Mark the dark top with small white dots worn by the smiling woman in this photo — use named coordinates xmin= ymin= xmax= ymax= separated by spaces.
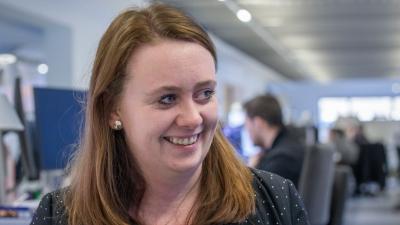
xmin=31 ymin=169 xmax=310 ymax=225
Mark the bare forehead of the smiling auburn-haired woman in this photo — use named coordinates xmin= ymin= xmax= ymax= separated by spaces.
xmin=127 ymin=40 xmax=215 ymax=88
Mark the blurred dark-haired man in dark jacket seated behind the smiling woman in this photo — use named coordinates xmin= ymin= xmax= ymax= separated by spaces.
xmin=243 ymin=95 xmax=305 ymax=186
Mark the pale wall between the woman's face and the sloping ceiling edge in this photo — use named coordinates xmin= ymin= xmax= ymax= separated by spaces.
xmin=211 ymin=34 xmax=286 ymax=120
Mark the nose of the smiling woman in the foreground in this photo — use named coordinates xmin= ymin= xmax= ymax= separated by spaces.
xmin=176 ymin=101 xmax=203 ymax=129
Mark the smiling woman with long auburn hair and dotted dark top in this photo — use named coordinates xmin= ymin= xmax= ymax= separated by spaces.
xmin=31 ymin=4 xmax=308 ymax=225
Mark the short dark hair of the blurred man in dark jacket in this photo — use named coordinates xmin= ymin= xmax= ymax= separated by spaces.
xmin=243 ymin=94 xmax=283 ymax=127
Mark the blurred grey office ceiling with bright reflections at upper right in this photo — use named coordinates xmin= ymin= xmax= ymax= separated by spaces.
xmin=163 ymin=0 xmax=400 ymax=81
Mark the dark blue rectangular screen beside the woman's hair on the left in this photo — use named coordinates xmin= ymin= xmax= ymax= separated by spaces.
xmin=34 ymin=87 xmax=85 ymax=170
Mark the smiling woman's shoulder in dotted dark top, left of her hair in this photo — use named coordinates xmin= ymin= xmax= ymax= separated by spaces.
xmin=31 ymin=189 xmax=67 ymax=225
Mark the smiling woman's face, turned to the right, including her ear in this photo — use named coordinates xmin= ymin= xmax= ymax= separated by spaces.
xmin=111 ymin=40 xmax=218 ymax=176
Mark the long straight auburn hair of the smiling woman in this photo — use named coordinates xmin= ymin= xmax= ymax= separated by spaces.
xmin=64 ymin=3 xmax=255 ymax=225
